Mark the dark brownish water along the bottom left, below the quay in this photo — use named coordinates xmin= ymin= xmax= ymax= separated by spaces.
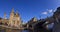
xmin=0 ymin=27 xmax=33 ymax=32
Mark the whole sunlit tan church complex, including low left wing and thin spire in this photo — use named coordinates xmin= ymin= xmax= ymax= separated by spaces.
xmin=0 ymin=8 xmax=22 ymax=27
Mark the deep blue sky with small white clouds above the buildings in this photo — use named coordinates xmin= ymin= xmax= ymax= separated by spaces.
xmin=0 ymin=0 xmax=60 ymax=23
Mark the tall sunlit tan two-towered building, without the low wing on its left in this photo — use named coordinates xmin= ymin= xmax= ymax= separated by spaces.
xmin=8 ymin=9 xmax=22 ymax=27
